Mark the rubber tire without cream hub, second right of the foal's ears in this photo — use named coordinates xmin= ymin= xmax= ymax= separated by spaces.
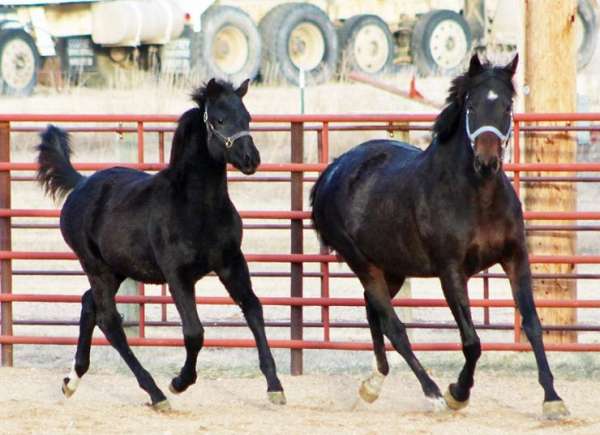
xmin=258 ymin=3 xmax=339 ymax=85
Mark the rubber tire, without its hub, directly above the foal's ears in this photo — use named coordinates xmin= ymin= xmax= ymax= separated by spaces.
xmin=191 ymin=6 xmax=262 ymax=83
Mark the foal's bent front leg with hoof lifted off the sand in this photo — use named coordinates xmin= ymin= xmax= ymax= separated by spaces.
xmin=169 ymin=277 xmax=204 ymax=394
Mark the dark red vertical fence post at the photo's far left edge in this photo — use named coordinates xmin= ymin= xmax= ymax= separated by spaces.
xmin=0 ymin=122 xmax=13 ymax=367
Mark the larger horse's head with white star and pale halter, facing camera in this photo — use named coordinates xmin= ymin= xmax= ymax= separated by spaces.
xmin=464 ymin=55 xmax=519 ymax=177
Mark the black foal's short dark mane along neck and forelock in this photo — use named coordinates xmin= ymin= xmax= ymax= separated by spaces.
xmin=170 ymin=79 xmax=235 ymax=165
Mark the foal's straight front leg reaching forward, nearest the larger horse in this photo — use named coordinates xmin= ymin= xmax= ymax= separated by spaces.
xmin=216 ymin=251 xmax=286 ymax=405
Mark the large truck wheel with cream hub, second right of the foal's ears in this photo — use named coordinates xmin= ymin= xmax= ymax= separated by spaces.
xmin=259 ymin=3 xmax=339 ymax=84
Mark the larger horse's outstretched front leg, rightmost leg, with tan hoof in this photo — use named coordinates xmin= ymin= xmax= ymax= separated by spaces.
xmin=502 ymin=246 xmax=569 ymax=419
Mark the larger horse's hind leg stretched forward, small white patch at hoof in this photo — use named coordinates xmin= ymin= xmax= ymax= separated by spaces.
xmin=358 ymin=266 xmax=446 ymax=410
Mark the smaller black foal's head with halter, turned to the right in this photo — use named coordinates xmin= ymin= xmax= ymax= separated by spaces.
xmin=195 ymin=79 xmax=260 ymax=175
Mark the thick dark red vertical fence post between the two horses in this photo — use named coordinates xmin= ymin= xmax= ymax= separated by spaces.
xmin=290 ymin=122 xmax=304 ymax=375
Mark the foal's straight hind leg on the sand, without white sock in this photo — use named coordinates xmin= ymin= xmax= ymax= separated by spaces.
xmin=89 ymin=272 xmax=170 ymax=411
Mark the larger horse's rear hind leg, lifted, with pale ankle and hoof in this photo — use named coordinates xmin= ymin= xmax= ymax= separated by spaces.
xmin=358 ymin=280 xmax=404 ymax=403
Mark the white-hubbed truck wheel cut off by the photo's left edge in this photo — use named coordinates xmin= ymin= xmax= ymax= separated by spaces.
xmin=0 ymin=29 xmax=40 ymax=96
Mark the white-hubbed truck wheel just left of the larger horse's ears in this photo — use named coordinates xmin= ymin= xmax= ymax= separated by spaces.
xmin=411 ymin=9 xmax=472 ymax=76
